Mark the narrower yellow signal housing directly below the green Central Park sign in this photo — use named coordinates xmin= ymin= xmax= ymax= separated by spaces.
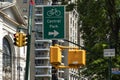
xmin=50 ymin=46 xmax=62 ymax=65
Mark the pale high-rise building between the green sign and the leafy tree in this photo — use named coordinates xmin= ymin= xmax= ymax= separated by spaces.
xmin=64 ymin=9 xmax=79 ymax=80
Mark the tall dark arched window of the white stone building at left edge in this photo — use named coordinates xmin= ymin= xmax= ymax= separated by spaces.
xmin=2 ymin=38 xmax=12 ymax=80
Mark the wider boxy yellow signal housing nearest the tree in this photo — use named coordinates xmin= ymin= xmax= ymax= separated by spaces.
xmin=68 ymin=49 xmax=86 ymax=67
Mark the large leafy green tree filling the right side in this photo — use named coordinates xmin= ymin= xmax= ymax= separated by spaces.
xmin=77 ymin=0 xmax=120 ymax=80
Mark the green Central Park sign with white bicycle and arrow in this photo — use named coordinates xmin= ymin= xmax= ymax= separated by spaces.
xmin=43 ymin=5 xmax=65 ymax=39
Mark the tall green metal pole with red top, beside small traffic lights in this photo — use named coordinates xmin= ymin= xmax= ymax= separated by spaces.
xmin=25 ymin=0 xmax=34 ymax=80
